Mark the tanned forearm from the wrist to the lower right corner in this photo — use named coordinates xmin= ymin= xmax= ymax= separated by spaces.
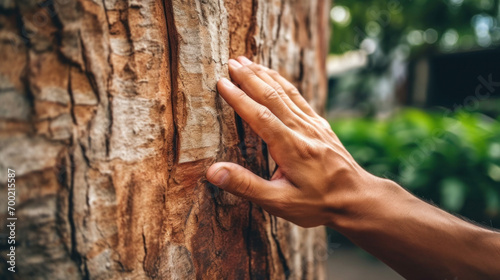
xmin=330 ymin=180 xmax=500 ymax=279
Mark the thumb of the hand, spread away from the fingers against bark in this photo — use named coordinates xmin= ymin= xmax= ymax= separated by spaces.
xmin=207 ymin=162 xmax=272 ymax=204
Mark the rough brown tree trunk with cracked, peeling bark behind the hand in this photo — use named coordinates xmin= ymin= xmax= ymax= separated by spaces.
xmin=0 ymin=0 xmax=329 ymax=279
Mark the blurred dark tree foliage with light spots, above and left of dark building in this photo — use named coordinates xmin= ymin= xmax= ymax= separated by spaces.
xmin=329 ymin=0 xmax=500 ymax=115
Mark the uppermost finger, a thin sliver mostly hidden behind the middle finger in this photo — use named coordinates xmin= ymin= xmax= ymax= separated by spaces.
xmin=238 ymin=56 xmax=307 ymax=121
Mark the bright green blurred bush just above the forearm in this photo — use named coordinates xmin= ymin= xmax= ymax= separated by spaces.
xmin=331 ymin=109 xmax=500 ymax=227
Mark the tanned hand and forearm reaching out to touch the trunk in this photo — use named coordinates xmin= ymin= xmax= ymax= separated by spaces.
xmin=207 ymin=57 xmax=500 ymax=279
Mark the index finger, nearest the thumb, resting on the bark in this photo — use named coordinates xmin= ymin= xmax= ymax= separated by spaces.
xmin=217 ymin=78 xmax=292 ymax=151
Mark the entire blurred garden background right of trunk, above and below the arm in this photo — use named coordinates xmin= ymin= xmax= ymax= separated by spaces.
xmin=327 ymin=0 xmax=500 ymax=279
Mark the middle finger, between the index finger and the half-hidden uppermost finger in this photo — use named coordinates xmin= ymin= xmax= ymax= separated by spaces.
xmin=229 ymin=59 xmax=293 ymax=123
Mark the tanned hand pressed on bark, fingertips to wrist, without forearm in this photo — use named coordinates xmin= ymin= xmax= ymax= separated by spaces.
xmin=207 ymin=57 xmax=386 ymax=227
